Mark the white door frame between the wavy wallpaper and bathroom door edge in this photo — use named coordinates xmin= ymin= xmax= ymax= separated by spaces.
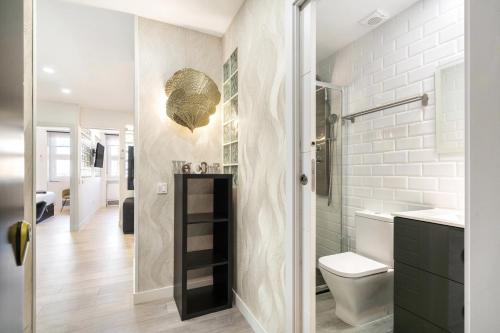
xmin=285 ymin=0 xmax=316 ymax=333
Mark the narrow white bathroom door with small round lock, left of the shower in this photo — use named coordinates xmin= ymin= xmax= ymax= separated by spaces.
xmin=299 ymin=1 xmax=316 ymax=333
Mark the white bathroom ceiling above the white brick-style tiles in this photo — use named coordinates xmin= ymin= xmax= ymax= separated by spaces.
xmin=316 ymin=0 xmax=417 ymax=61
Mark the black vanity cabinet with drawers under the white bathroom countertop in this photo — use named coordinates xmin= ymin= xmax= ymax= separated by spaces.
xmin=394 ymin=217 xmax=464 ymax=333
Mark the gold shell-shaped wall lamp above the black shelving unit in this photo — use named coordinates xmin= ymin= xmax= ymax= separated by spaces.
xmin=165 ymin=68 xmax=220 ymax=132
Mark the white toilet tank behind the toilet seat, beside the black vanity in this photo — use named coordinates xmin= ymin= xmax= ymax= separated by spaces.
xmin=354 ymin=211 xmax=394 ymax=267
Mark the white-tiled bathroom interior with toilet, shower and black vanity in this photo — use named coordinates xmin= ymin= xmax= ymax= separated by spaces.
xmin=308 ymin=0 xmax=465 ymax=333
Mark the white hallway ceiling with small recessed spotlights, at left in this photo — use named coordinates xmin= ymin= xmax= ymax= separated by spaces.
xmin=36 ymin=0 xmax=134 ymax=112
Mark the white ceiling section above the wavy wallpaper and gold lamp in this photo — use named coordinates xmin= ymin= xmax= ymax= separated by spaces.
xmin=67 ymin=0 xmax=245 ymax=37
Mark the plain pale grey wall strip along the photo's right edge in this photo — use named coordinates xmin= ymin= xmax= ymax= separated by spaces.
xmin=465 ymin=0 xmax=500 ymax=333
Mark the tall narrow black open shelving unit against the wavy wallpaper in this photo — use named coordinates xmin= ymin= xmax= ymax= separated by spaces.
xmin=174 ymin=174 xmax=233 ymax=320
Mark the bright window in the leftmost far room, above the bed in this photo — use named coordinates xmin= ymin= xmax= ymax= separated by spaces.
xmin=47 ymin=131 xmax=71 ymax=182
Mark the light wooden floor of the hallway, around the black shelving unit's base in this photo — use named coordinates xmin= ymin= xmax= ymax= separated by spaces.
xmin=36 ymin=208 xmax=252 ymax=333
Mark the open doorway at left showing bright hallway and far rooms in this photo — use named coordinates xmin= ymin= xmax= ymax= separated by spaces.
xmin=34 ymin=0 xmax=134 ymax=333
